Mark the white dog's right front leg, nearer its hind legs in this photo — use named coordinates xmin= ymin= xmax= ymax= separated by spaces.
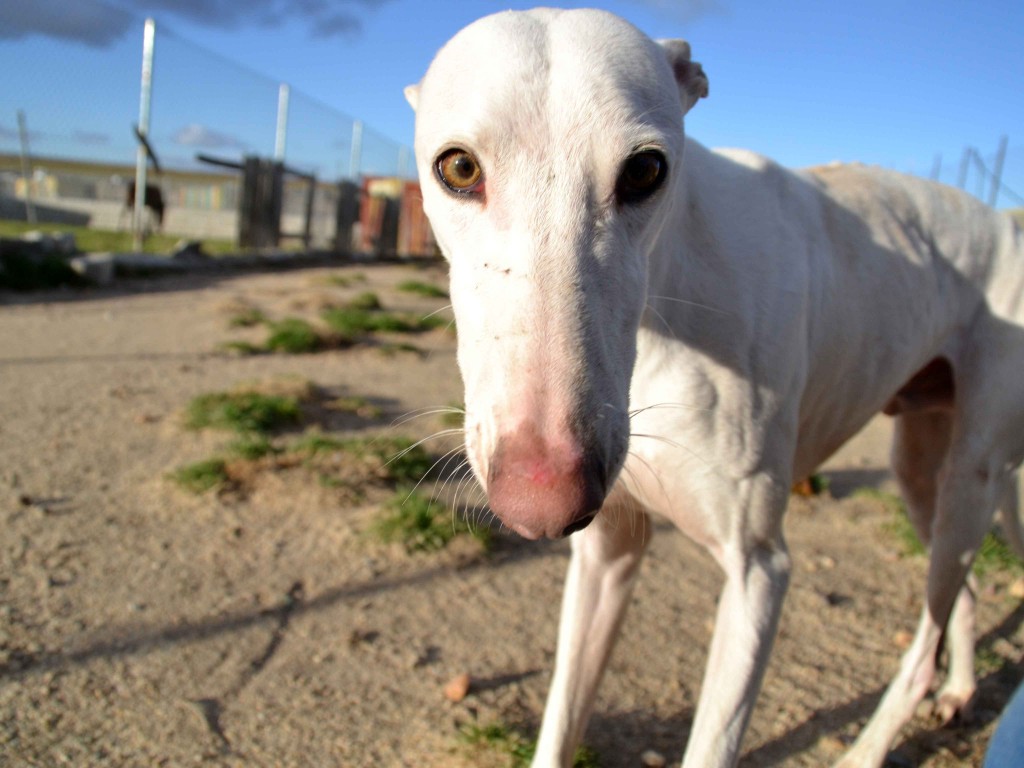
xmin=683 ymin=534 xmax=790 ymax=768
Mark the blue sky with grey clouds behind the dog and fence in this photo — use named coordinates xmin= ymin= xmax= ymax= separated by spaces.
xmin=0 ymin=0 xmax=1024 ymax=207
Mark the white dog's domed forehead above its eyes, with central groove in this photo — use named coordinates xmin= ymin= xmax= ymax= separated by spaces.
xmin=418 ymin=9 xmax=681 ymax=153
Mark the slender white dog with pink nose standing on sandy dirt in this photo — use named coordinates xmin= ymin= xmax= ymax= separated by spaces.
xmin=407 ymin=10 xmax=1024 ymax=768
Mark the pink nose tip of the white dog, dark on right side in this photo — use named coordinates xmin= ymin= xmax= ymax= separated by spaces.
xmin=487 ymin=429 xmax=606 ymax=539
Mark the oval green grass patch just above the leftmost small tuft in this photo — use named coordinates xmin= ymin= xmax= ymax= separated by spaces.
xmin=185 ymin=391 xmax=301 ymax=434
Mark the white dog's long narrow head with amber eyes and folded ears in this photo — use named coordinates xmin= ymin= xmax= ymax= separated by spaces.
xmin=407 ymin=10 xmax=708 ymax=538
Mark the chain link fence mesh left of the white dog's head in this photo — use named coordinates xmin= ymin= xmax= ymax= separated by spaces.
xmin=0 ymin=12 xmax=415 ymax=247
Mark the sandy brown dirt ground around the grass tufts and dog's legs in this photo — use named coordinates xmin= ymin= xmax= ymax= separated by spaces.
xmin=0 ymin=265 xmax=1024 ymax=768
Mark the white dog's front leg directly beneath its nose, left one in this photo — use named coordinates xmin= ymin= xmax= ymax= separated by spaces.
xmin=532 ymin=502 xmax=651 ymax=768
